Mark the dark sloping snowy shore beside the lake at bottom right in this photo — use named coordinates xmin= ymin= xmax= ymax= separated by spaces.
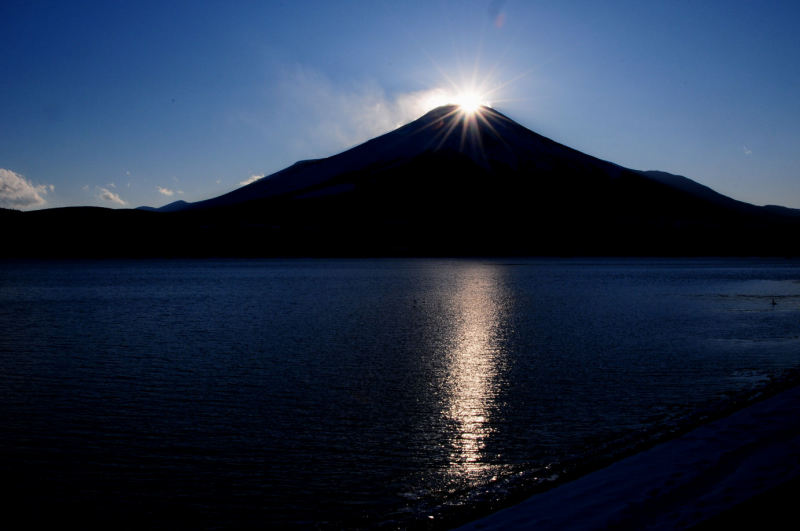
xmin=457 ymin=374 xmax=800 ymax=530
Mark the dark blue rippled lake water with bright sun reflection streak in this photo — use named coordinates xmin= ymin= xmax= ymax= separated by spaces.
xmin=0 ymin=259 xmax=800 ymax=528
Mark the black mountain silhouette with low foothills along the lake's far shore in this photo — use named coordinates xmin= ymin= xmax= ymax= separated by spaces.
xmin=1 ymin=106 xmax=800 ymax=256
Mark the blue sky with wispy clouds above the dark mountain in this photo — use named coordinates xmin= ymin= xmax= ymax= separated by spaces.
xmin=0 ymin=0 xmax=800 ymax=208
